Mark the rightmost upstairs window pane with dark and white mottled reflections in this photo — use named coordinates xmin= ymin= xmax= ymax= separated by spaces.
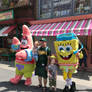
xmin=74 ymin=0 xmax=91 ymax=14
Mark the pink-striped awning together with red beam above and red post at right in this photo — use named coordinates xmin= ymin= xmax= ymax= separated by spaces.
xmin=30 ymin=15 xmax=92 ymax=68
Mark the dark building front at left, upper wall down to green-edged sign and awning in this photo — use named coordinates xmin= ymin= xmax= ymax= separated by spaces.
xmin=0 ymin=0 xmax=36 ymax=60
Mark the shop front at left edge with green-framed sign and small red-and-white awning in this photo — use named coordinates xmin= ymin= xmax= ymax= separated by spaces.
xmin=0 ymin=10 xmax=16 ymax=61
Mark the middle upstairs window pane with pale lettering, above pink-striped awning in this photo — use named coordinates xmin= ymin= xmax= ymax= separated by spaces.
xmin=53 ymin=0 xmax=72 ymax=17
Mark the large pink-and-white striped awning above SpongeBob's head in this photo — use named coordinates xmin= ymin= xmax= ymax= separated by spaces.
xmin=30 ymin=19 xmax=92 ymax=36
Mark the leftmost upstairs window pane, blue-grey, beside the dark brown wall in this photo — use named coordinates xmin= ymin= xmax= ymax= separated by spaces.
xmin=40 ymin=0 xmax=52 ymax=18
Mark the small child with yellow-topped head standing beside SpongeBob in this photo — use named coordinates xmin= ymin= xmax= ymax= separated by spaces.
xmin=48 ymin=55 xmax=57 ymax=91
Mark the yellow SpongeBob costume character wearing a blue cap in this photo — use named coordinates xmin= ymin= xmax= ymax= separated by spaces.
xmin=54 ymin=33 xmax=83 ymax=92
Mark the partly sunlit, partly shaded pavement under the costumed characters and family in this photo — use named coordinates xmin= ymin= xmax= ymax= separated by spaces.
xmin=0 ymin=61 xmax=92 ymax=92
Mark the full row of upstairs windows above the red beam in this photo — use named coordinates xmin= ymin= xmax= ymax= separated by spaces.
xmin=37 ymin=0 xmax=92 ymax=19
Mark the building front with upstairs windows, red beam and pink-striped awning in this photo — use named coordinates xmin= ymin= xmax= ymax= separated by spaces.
xmin=29 ymin=0 xmax=92 ymax=70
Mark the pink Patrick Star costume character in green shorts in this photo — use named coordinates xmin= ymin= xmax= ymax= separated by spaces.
xmin=10 ymin=25 xmax=36 ymax=86
